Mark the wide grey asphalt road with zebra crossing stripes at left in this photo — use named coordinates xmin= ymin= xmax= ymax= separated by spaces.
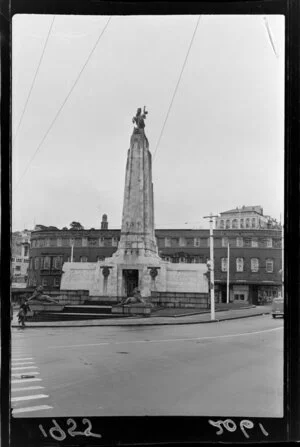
xmin=11 ymin=315 xmax=283 ymax=417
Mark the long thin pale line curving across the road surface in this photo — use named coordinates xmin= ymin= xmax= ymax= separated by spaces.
xmin=48 ymin=326 xmax=283 ymax=349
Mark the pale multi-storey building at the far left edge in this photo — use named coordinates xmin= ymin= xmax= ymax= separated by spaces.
xmin=11 ymin=230 xmax=30 ymax=288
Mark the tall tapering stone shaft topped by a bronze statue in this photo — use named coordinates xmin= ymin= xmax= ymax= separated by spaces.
xmin=115 ymin=107 xmax=159 ymax=262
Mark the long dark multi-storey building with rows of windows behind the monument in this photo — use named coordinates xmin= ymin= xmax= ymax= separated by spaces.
xmin=28 ymin=215 xmax=282 ymax=304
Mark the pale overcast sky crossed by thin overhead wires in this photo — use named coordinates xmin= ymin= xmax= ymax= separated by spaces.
xmin=12 ymin=15 xmax=285 ymax=231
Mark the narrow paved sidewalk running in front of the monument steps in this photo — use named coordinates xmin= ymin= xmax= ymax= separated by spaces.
xmin=12 ymin=306 xmax=271 ymax=328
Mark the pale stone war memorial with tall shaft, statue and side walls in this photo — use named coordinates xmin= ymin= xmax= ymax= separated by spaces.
xmin=60 ymin=107 xmax=208 ymax=308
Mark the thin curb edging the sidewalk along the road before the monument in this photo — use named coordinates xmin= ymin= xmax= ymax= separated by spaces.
xmin=11 ymin=312 xmax=271 ymax=329
